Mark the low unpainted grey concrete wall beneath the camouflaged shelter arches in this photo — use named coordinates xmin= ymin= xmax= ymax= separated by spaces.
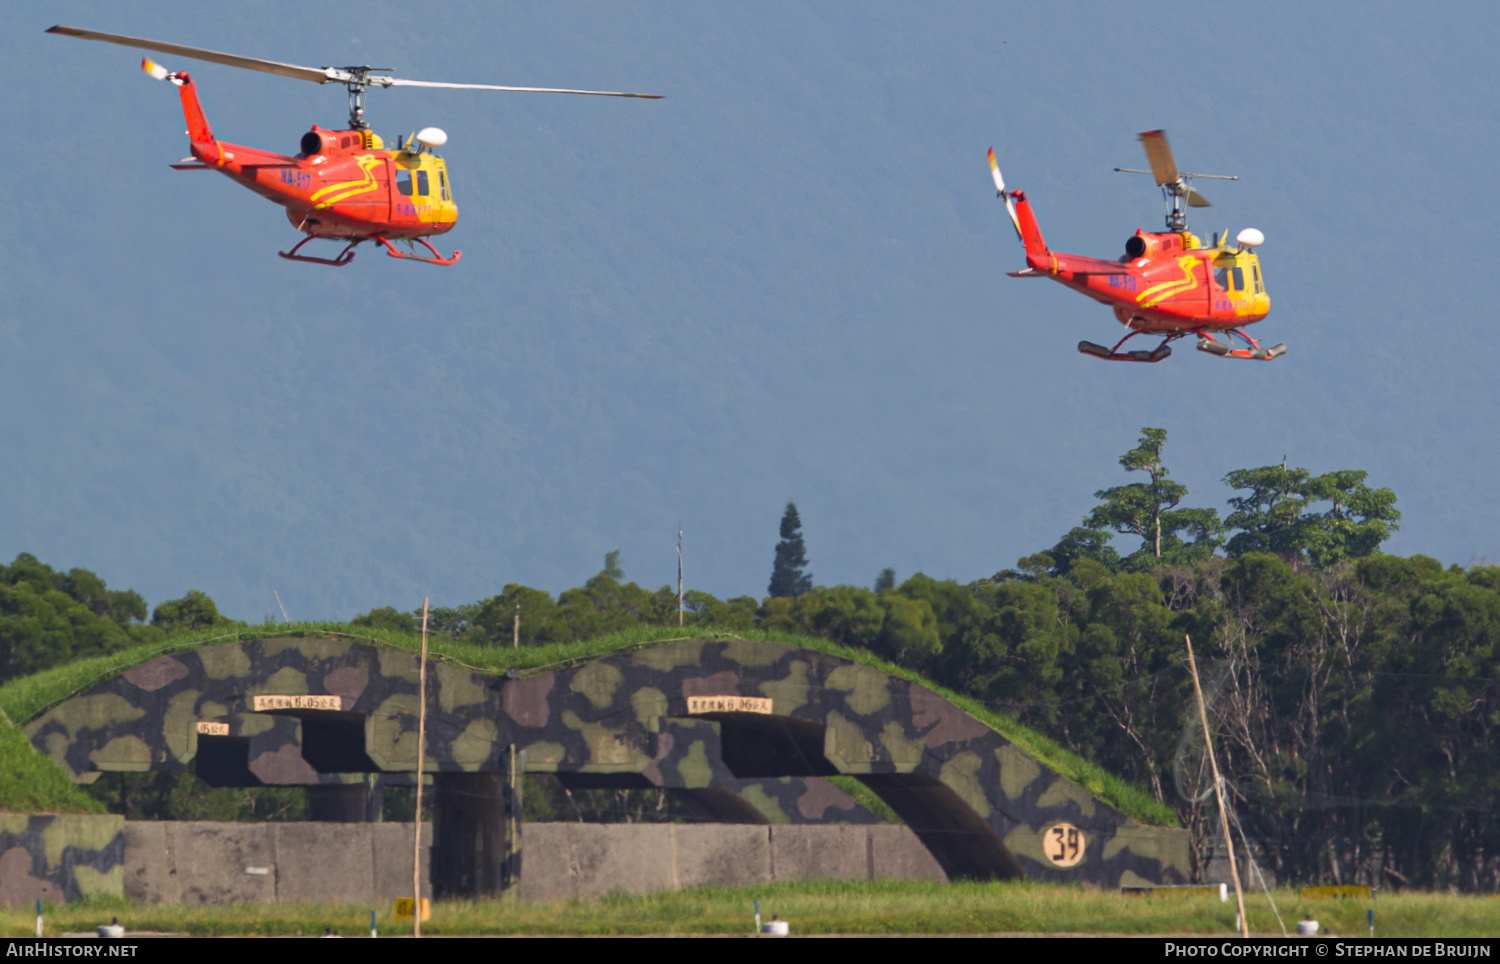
xmin=125 ymin=820 xmax=945 ymax=904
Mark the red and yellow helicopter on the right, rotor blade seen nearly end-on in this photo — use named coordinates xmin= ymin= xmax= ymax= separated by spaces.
xmin=990 ymin=130 xmax=1287 ymax=361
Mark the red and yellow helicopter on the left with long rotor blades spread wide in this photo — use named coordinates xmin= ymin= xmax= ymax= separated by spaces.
xmin=47 ymin=27 xmax=662 ymax=265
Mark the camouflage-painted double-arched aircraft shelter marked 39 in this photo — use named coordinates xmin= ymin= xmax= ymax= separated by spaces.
xmin=26 ymin=636 xmax=1190 ymax=895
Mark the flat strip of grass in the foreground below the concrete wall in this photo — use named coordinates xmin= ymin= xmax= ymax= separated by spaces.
xmin=0 ymin=882 xmax=1500 ymax=937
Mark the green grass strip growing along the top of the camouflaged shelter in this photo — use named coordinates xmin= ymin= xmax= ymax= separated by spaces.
xmin=0 ymin=624 xmax=1178 ymax=826
